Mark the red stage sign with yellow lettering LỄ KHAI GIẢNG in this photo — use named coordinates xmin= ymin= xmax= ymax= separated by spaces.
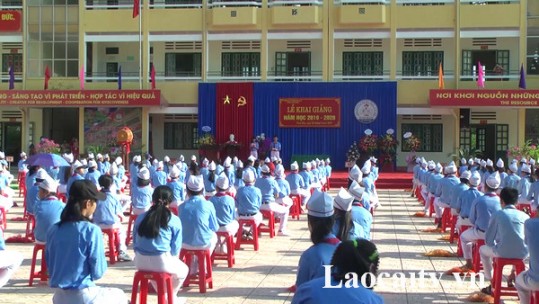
xmin=279 ymin=98 xmax=341 ymax=128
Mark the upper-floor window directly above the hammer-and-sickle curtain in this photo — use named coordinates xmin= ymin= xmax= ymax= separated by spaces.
xmin=221 ymin=53 xmax=260 ymax=77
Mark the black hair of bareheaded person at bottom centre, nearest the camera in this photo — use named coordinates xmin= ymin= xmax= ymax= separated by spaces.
xmin=331 ymin=239 xmax=380 ymax=287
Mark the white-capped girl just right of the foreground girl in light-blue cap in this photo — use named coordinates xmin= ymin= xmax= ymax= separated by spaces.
xmin=332 ymin=187 xmax=363 ymax=241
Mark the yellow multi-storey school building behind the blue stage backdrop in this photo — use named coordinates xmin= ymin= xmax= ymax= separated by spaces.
xmin=0 ymin=0 xmax=539 ymax=166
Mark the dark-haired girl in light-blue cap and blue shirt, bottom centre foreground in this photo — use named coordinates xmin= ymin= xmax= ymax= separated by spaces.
xmin=291 ymin=190 xmax=341 ymax=290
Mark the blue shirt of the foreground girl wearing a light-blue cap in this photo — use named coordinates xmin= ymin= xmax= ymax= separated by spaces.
xmin=296 ymin=233 xmax=340 ymax=288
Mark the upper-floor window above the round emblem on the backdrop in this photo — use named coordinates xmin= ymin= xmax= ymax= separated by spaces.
xmin=342 ymin=52 xmax=384 ymax=76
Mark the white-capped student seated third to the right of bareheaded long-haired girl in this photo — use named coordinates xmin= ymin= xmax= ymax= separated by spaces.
xmin=235 ymin=170 xmax=262 ymax=226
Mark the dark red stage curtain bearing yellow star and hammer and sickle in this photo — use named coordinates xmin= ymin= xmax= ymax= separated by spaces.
xmin=216 ymin=82 xmax=254 ymax=159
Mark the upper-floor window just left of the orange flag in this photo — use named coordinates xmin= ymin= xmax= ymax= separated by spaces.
xmin=402 ymin=51 xmax=444 ymax=76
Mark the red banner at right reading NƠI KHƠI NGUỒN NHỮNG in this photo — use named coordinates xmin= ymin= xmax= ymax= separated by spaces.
xmin=429 ymin=90 xmax=539 ymax=108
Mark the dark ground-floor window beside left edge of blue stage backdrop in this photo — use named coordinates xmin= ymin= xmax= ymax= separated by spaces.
xmin=164 ymin=122 xmax=198 ymax=150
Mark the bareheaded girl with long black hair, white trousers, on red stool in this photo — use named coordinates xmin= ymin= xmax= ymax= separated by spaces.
xmin=133 ymin=186 xmax=189 ymax=303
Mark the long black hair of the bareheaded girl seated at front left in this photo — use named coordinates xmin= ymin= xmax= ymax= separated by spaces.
xmin=137 ymin=186 xmax=173 ymax=239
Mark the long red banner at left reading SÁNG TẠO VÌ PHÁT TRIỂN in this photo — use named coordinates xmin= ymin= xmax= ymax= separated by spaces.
xmin=0 ymin=90 xmax=161 ymax=108
